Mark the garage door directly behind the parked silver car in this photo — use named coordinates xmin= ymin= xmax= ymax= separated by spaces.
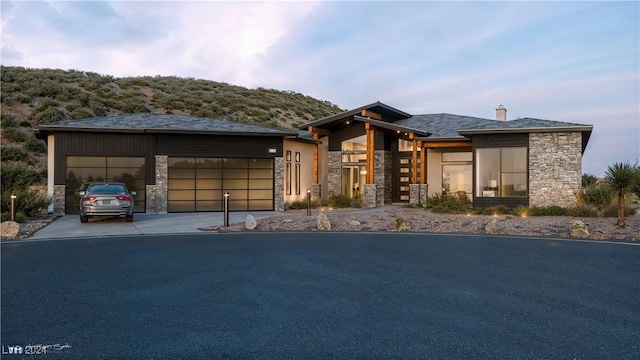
xmin=65 ymin=156 xmax=146 ymax=214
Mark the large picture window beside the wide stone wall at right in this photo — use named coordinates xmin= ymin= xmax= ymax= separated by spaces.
xmin=476 ymin=147 xmax=528 ymax=197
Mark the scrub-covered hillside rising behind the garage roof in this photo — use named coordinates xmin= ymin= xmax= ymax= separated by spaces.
xmin=0 ymin=66 xmax=342 ymax=173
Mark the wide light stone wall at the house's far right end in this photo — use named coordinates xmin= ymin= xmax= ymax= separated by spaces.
xmin=529 ymin=132 xmax=582 ymax=207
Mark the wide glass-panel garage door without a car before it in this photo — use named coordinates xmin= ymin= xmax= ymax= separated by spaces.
xmin=168 ymin=157 xmax=274 ymax=212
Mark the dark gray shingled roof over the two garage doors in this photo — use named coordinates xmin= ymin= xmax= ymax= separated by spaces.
xmin=39 ymin=114 xmax=297 ymax=136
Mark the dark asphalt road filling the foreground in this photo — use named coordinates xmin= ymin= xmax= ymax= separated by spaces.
xmin=1 ymin=233 xmax=640 ymax=359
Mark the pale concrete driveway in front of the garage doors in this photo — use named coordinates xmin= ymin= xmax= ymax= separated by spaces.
xmin=30 ymin=211 xmax=285 ymax=240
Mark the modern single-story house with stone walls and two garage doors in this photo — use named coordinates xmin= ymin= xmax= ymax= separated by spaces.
xmin=39 ymin=102 xmax=593 ymax=213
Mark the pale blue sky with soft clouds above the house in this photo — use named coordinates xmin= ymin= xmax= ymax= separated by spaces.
xmin=0 ymin=0 xmax=640 ymax=176
